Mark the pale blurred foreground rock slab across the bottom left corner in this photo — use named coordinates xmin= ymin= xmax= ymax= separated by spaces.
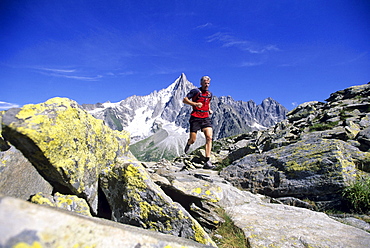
xmin=0 ymin=196 xmax=214 ymax=248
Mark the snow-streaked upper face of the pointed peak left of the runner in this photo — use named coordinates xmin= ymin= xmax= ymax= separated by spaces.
xmin=83 ymin=74 xmax=195 ymax=140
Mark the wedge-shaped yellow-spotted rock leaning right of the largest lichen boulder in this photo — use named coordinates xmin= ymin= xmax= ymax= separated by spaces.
xmin=100 ymin=159 xmax=214 ymax=245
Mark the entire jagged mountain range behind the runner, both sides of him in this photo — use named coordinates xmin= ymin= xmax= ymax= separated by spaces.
xmin=83 ymin=74 xmax=287 ymax=161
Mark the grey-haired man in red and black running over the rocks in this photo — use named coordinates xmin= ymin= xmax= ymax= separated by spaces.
xmin=183 ymin=76 xmax=214 ymax=169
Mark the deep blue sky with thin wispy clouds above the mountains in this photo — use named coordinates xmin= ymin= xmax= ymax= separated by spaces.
xmin=0 ymin=0 xmax=370 ymax=109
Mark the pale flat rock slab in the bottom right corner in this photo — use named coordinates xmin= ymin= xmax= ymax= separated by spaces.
xmin=226 ymin=203 xmax=370 ymax=248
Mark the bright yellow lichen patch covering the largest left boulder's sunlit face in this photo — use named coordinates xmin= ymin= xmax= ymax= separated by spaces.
xmin=13 ymin=98 xmax=129 ymax=172
